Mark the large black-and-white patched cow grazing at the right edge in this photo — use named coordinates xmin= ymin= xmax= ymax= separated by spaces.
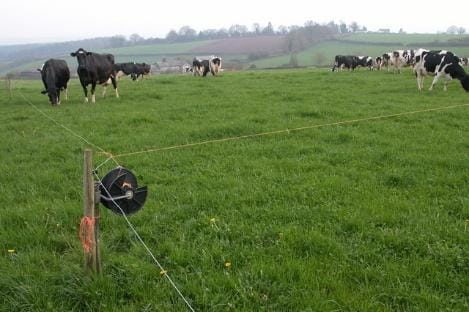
xmin=414 ymin=51 xmax=469 ymax=92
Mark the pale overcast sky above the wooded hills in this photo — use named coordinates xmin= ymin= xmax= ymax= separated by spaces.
xmin=0 ymin=0 xmax=469 ymax=44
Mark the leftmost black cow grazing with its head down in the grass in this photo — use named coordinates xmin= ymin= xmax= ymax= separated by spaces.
xmin=38 ymin=59 xmax=70 ymax=105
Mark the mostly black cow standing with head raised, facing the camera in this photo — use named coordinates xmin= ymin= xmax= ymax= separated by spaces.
xmin=70 ymin=48 xmax=119 ymax=103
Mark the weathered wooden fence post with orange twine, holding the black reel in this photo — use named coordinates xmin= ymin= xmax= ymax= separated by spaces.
xmin=83 ymin=149 xmax=101 ymax=273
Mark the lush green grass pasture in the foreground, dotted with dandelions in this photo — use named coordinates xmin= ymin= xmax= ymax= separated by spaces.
xmin=0 ymin=70 xmax=469 ymax=311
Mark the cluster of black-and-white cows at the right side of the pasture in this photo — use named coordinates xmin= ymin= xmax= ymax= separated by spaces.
xmin=332 ymin=49 xmax=469 ymax=92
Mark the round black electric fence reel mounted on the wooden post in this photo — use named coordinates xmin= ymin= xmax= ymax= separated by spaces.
xmin=99 ymin=167 xmax=148 ymax=215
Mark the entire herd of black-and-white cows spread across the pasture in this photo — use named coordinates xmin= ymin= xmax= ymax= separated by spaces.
xmin=38 ymin=48 xmax=469 ymax=105
